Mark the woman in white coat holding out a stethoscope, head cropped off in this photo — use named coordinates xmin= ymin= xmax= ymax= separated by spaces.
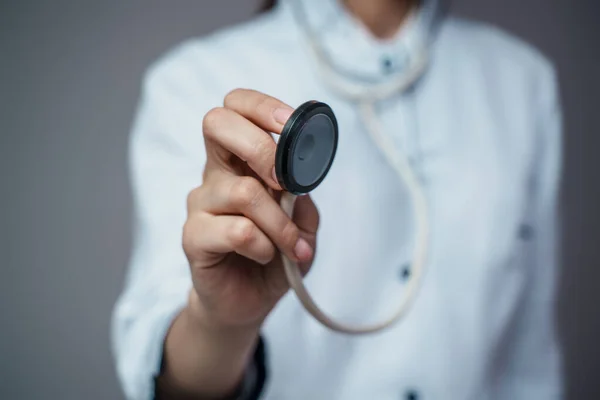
xmin=113 ymin=0 xmax=561 ymax=400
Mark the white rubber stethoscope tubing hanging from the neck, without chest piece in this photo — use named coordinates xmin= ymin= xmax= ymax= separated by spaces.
xmin=281 ymin=1 xmax=429 ymax=334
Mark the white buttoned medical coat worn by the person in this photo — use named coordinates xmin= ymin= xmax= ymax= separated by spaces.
xmin=113 ymin=0 xmax=562 ymax=400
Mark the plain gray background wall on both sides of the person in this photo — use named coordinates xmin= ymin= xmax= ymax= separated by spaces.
xmin=0 ymin=0 xmax=600 ymax=399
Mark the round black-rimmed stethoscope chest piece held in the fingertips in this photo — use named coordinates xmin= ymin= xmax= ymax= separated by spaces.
xmin=275 ymin=101 xmax=338 ymax=194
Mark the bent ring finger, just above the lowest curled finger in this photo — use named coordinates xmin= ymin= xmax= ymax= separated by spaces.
xmin=188 ymin=173 xmax=311 ymax=261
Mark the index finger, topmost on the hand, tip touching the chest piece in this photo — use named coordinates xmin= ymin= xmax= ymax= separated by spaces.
xmin=223 ymin=89 xmax=294 ymax=134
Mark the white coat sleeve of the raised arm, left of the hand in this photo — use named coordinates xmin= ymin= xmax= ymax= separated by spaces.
xmin=112 ymin=54 xmax=208 ymax=400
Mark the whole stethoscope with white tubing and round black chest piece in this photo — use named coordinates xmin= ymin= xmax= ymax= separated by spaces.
xmin=275 ymin=0 xmax=429 ymax=334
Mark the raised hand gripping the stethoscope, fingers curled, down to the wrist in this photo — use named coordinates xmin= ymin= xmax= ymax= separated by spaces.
xmin=183 ymin=89 xmax=319 ymax=328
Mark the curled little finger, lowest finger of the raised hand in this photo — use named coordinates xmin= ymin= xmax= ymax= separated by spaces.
xmin=184 ymin=213 xmax=276 ymax=267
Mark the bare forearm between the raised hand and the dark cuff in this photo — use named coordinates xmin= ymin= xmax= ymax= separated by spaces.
xmin=161 ymin=290 xmax=259 ymax=400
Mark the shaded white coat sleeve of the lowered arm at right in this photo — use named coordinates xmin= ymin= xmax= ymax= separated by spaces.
xmin=494 ymin=66 xmax=563 ymax=400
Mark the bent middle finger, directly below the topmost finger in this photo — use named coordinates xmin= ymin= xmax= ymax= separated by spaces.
xmin=203 ymin=108 xmax=281 ymax=190
